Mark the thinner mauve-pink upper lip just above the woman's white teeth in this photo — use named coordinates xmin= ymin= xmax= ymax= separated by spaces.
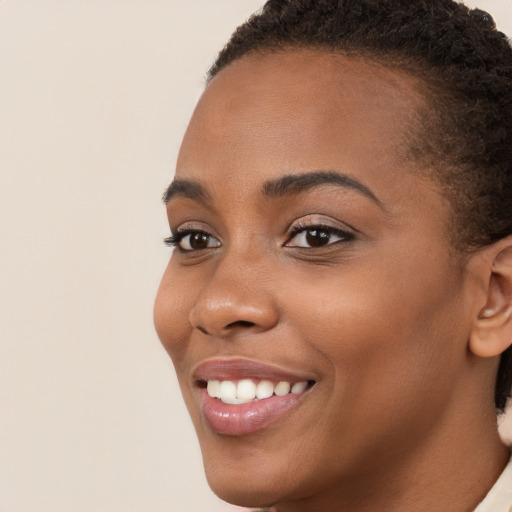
xmin=192 ymin=358 xmax=316 ymax=382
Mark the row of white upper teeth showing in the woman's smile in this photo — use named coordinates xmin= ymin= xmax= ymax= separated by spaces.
xmin=206 ymin=379 xmax=308 ymax=404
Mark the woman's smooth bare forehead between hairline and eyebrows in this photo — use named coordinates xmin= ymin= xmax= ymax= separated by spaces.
xmin=176 ymin=50 xmax=428 ymax=198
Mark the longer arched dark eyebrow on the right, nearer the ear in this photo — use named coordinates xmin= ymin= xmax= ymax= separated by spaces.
xmin=262 ymin=170 xmax=383 ymax=208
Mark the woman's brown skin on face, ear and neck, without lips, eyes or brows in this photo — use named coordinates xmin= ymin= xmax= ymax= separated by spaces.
xmin=155 ymin=51 xmax=512 ymax=512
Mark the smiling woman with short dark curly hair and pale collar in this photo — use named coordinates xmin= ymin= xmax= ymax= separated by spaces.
xmin=155 ymin=0 xmax=512 ymax=512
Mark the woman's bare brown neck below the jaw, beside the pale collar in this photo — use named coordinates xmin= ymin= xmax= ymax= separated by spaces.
xmin=272 ymin=406 xmax=510 ymax=512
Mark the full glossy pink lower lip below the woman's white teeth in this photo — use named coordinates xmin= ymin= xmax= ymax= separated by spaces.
xmin=201 ymin=390 xmax=302 ymax=436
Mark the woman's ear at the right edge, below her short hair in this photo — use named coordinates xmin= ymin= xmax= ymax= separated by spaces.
xmin=469 ymin=237 xmax=512 ymax=357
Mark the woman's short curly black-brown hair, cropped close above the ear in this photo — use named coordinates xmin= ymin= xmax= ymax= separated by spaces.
xmin=208 ymin=0 xmax=512 ymax=411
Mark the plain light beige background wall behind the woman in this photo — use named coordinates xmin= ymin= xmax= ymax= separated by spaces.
xmin=0 ymin=0 xmax=512 ymax=512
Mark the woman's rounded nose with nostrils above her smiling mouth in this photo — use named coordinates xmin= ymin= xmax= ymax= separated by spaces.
xmin=189 ymin=260 xmax=279 ymax=338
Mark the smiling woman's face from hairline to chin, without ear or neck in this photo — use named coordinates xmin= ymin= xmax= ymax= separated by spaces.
xmin=155 ymin=51 xmax=478 ymax=510
